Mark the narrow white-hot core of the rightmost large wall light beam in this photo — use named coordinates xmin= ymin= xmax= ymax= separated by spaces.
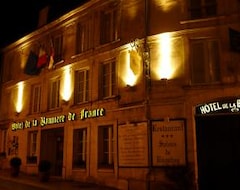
xmin=157 ymin=33 xmax=174 ymax=79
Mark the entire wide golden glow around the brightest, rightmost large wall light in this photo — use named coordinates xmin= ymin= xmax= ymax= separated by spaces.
xmin=150 ymin=33 xmax=184 ymax=80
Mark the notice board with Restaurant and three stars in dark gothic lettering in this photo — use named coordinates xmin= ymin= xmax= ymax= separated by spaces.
xmin=151 ymin=120 xmax=186 ymax=166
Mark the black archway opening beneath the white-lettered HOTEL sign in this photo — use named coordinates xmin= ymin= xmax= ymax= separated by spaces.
xmin=196 ymin=115 xmax=240 ymax=190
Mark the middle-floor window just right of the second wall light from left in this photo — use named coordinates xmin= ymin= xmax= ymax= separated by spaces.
xmin=74 ymin=70 xmax=89 ymax=104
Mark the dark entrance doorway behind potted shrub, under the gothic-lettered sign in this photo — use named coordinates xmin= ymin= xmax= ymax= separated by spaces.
xmin=40 ymin=128 xmax=64 ymax=176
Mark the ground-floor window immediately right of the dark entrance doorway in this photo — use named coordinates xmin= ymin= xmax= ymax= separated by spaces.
xmin=72 ymin=128 xmax=87 ymax=168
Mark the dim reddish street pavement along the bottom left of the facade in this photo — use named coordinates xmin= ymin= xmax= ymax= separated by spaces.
xmin=0 ymin=169 xmax=117 ymax=190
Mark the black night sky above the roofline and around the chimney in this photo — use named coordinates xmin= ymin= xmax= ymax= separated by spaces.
xmin=0 ymin=0 xmax=88 ymax=48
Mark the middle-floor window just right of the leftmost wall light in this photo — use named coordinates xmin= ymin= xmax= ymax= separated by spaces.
xmin=31 ymin=84 xmax=41 ymax=113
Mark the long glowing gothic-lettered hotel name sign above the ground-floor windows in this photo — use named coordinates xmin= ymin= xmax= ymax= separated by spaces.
xmin=11 ymin=108 xmax=106 ymax=131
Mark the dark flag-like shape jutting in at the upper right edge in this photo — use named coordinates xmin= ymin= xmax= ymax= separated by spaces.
xmin=229 ymin=28 xmax=240 ymax=53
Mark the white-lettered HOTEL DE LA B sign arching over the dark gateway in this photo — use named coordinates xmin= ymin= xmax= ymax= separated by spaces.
xmin=196 ymin=98 xmax=240 ymax=115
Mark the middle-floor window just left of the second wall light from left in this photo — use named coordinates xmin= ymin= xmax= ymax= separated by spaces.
xmin=48 ymin=78 xmax=60 ymax=110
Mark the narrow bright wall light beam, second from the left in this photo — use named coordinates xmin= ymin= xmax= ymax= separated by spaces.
xmin=61 ymin=66 xmax=73 ymax=101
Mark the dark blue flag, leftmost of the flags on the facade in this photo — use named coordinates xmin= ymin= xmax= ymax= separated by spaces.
xmin=24 ymin=51 xmax=40 ymax=75
